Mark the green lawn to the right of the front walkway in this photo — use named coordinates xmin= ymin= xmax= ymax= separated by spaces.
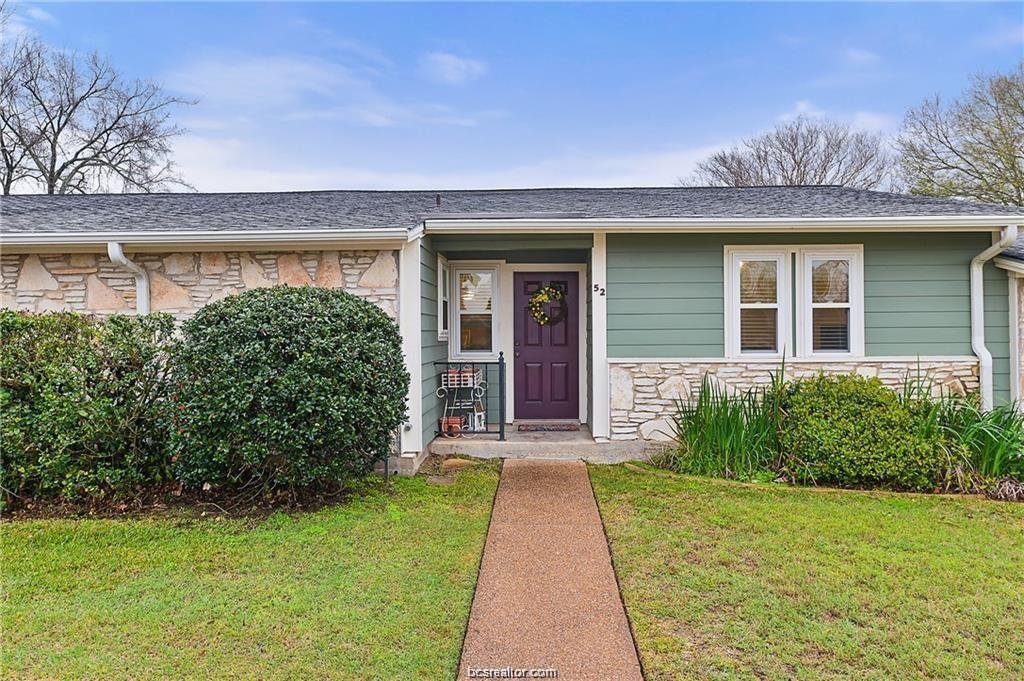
xmin=590 ymin=466 xmax=1024 ymax=679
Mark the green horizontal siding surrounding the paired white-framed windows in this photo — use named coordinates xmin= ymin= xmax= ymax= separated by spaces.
xmin=607 ymin=233 xmax=1010 ymax=399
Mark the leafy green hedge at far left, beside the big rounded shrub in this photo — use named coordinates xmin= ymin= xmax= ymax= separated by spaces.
xmin=0 ymin=310 xmax=174 ymax=501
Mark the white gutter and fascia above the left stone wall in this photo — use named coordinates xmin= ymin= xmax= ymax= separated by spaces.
xmin=0 ymin=227 xmax=409 ymax=248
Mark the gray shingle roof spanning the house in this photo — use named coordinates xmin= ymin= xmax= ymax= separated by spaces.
xmin=0 ymin=186 xmax=1021 ymax=232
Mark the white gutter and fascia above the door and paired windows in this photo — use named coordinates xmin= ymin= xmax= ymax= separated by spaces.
xmin=424 ymin=215 xmax=1024 ymax=235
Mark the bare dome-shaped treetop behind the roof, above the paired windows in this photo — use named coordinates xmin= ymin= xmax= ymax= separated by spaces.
xmin=684 ymin=116 xmax=893 ymax=189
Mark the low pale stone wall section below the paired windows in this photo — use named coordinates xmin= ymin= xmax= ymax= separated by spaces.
xmin=609 ymin=359 xmax=979 ymax=440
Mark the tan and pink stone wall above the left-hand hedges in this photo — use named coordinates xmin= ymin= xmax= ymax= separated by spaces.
xmin=0 ymin=251 xmax=398 ymax=318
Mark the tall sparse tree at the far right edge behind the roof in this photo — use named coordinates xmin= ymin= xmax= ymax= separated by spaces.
xmin=898 ymin=61 xmax=1024 ymax=206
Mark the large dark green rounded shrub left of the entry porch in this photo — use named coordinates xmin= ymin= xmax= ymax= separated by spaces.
xmin=172 ymin=287 xmax=409 ymax=492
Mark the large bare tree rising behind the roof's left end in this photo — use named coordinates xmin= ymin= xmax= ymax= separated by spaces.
xmin=0 ymin=31 xmax=191 ymax=194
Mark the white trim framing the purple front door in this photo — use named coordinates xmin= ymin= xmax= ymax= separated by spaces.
xmin=498 ymin=262 xmax=590 ymax=423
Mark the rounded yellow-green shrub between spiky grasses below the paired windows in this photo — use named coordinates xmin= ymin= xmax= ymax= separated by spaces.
xmin=780 ymin=375 xmax=950 ymax=491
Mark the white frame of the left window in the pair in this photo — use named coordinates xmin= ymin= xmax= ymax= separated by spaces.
xmin=725 ymin=246 xmax=793 ymax=358
